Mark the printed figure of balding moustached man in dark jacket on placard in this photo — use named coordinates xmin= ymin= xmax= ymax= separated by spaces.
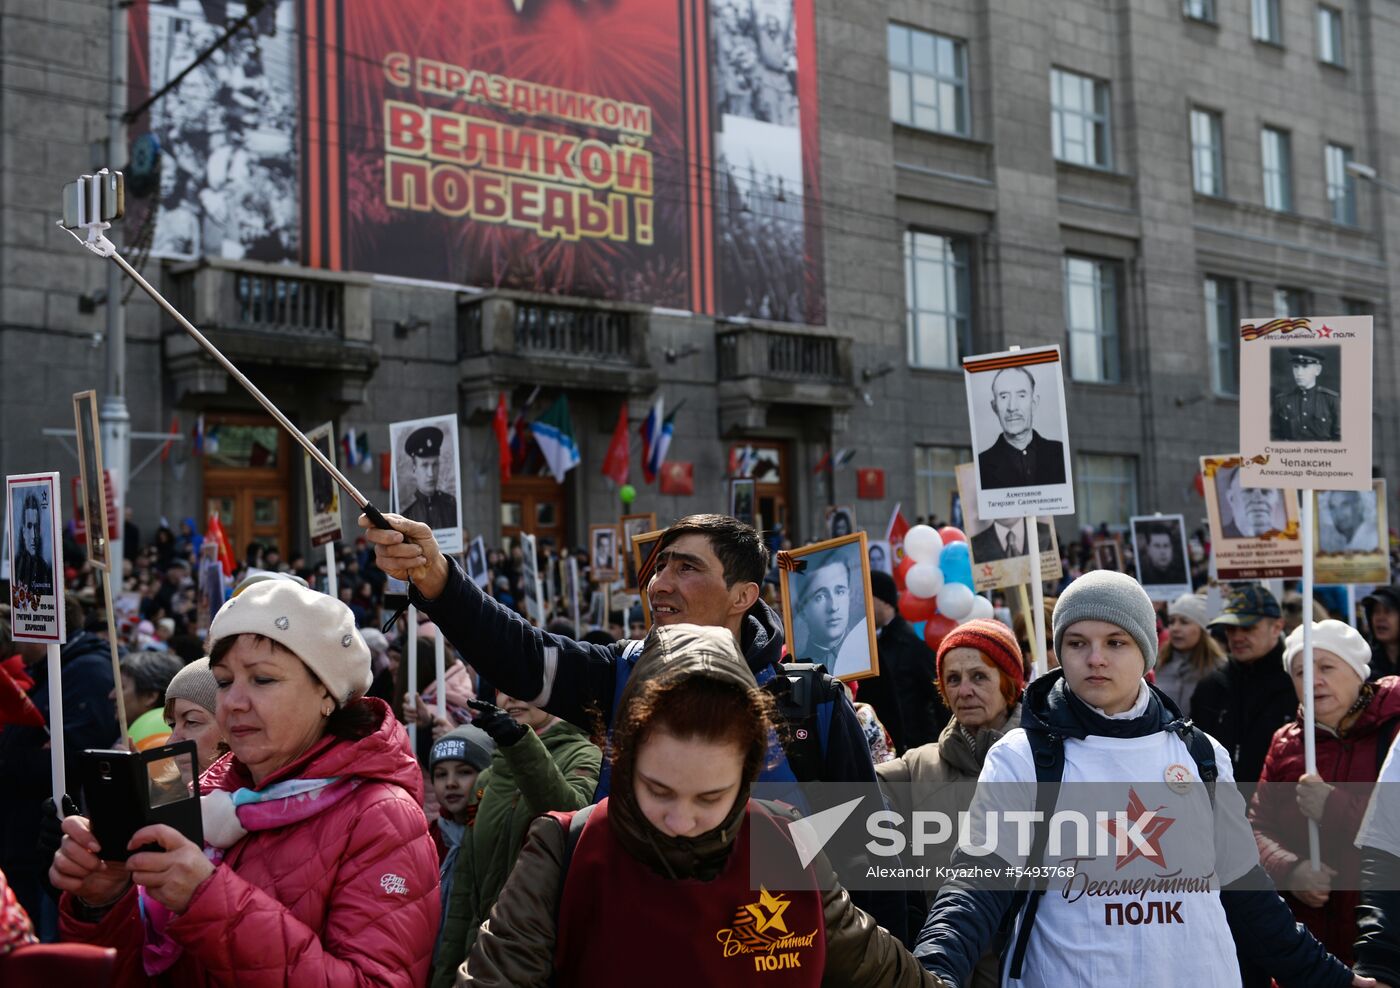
xmin=977 ymin=367 xmax=1064 ymax=490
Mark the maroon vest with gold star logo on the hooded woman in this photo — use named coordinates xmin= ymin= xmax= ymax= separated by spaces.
xmin=552 ymin=799 xmax=826 ymax=988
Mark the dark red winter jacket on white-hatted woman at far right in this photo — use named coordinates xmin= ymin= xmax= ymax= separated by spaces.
xmin=1249 ymin=676 xmax=1400 ymax=964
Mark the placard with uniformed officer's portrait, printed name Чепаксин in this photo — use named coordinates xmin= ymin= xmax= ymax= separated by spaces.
xmin=1239 ymin=316 xmax=1372 ymax=491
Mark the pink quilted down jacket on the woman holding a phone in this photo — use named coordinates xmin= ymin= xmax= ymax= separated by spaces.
xmin=59 ymin=700 xmax=440 ymax=988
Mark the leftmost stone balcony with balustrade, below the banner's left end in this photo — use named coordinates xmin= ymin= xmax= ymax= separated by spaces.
xmin=162 ymin=257 xmax=379 ymax=403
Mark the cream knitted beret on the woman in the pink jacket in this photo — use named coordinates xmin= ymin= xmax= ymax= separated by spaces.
xmin=209 ymin=579 xmax=372 ymax=705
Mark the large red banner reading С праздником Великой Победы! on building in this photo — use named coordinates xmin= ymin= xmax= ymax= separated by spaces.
xmin=132 ymin=0 xmax=825 ymax=323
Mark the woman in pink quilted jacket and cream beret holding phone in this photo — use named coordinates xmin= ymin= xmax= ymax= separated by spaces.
xmin=49 ymin=581 xmax=440 ymax=988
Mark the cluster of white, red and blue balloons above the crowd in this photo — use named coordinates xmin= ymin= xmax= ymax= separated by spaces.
xmin=895 ymin=525 xmax=993 ymax=648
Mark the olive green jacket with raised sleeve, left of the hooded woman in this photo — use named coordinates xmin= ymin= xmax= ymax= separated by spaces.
xmin=433 ymin=721 xmax=603 ymax=988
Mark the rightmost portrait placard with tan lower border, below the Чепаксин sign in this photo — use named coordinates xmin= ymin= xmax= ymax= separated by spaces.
xmin=1313 ymin=480 xmax=1390 ymax=585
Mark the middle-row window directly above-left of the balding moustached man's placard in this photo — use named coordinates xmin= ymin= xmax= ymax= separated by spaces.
xmin=904 ymin=230 xmax=972 ymax=369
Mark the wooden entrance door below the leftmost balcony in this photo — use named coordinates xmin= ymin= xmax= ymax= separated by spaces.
xmin=203 ymin=413 xmax=294 ymax=561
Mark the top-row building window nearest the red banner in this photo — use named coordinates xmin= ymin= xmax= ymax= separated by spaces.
xmin=889 ymin=24 xmax=970 ymax=137
